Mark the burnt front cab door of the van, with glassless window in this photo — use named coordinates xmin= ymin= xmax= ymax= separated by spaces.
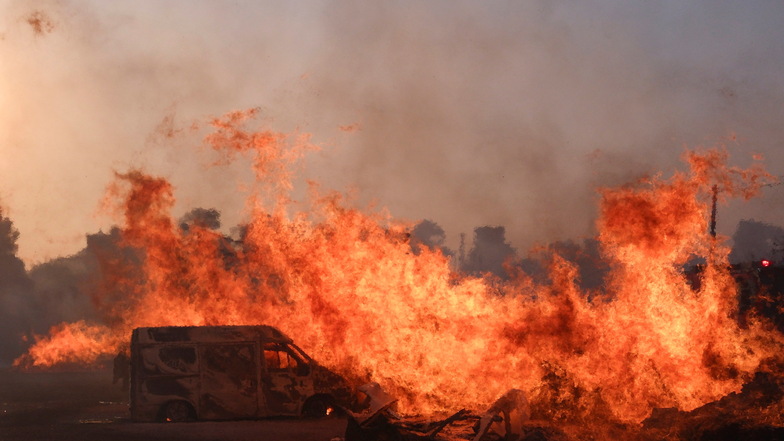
xmin=262 ymin=343 xmax=313 ymax=415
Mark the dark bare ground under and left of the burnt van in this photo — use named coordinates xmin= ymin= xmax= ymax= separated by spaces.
xmin=0 ymin=369 xmax=346 ymax=441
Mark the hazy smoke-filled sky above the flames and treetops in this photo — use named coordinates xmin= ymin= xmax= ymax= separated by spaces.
xmin=0 ymin=0 xmax=784 ymax=265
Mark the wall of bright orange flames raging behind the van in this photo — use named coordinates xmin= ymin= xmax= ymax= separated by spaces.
xmin=13 ymin=111 xmax=782 ymax=421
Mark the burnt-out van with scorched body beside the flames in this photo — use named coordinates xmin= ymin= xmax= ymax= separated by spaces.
xmin=130 ymin=326 xmax=352 ymax=421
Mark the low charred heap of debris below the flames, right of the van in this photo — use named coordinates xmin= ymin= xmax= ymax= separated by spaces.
xmin=344 ymin=372 xmax=784 ymax=441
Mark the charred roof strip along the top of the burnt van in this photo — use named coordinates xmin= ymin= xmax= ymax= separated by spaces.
xmin=131 ymin=325 xmax=292 ymax=344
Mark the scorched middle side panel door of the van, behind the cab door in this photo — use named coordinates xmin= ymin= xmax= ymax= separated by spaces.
xmin=199 ymin=343 xmax=259 ymax=419
